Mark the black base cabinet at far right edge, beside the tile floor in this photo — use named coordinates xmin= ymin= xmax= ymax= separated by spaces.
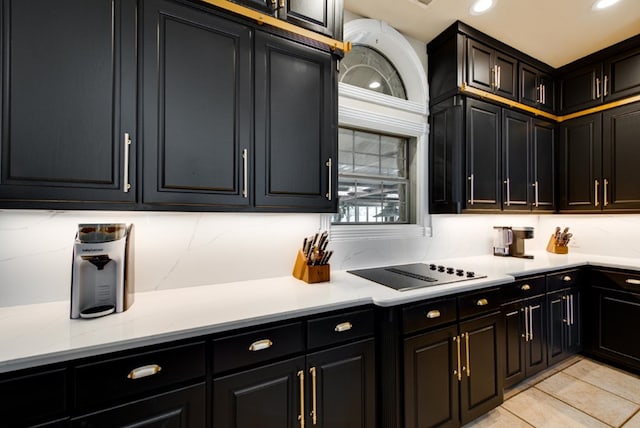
xmin=589 ymin=269 xmax=640 ymax=371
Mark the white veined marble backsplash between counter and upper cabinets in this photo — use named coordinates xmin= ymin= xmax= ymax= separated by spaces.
xmin=0 ymin=210 xmax=640 ymax=306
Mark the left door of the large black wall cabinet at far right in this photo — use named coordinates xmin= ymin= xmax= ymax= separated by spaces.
xmin=558 ymin=114 xmax=603 ymax=211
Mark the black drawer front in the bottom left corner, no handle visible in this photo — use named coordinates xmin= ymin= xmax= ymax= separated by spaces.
xmin=0 ymin=369 xmax=68 ymax=426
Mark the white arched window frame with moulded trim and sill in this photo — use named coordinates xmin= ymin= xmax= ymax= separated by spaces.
xmin=320 ymin=19 xmax=431 ymax=241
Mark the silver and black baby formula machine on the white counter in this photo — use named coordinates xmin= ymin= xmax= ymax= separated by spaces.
xmin=71 ymin=223 xmax=134 ymax=319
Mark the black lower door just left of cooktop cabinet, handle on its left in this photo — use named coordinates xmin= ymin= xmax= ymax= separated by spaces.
xmin=306 ymin=339 xmax=376 ymax=428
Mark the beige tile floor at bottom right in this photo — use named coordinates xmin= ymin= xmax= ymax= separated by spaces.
xmin=465 ymin=356 xmax=640 ymax=428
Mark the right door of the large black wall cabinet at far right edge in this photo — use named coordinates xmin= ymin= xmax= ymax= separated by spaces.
xmin=602 ymin=103 xmax=640 ymax=210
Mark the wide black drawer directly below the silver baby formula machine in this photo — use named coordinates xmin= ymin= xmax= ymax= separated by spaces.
xmin=74 ymin=342 xmax=205 ymax=408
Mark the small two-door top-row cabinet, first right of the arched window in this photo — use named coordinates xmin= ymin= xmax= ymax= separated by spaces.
xmin=467 ymin=39 xmax=518 ymax=100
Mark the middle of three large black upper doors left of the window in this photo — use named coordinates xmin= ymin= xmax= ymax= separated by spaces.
xmin=143 ymin=0 xmax=252 ymax=206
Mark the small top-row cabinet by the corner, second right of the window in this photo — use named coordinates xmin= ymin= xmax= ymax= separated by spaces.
xmin=519 ymin=63 xmax=555 ymax=113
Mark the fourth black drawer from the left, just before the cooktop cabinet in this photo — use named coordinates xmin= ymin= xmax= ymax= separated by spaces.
xmin=307 ymin=309 xmax=374 ymax=349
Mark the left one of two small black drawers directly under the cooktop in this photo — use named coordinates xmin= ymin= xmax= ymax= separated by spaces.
xmin=402 ymin=297 xmax=457 ymax=334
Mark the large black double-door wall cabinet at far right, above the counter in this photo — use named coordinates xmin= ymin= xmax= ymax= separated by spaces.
xmin=560 ymin=103 xmax=640 ymax=212
